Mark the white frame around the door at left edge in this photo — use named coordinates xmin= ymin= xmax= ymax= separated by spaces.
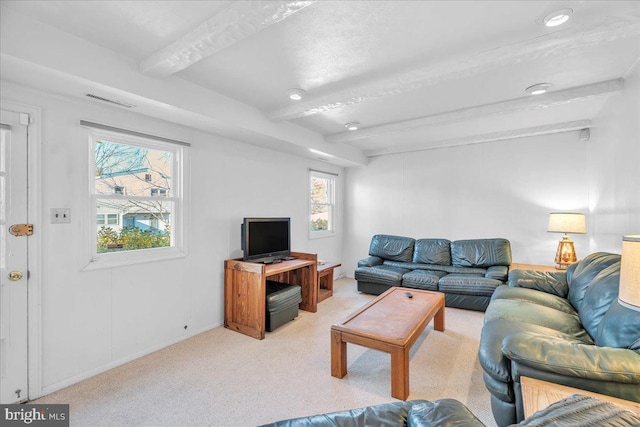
xmin=0 ymin=98 xmax=44 ymax=400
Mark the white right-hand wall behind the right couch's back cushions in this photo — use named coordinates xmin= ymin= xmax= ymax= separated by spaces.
xmin=588 ymin=63 xmax=640 ymax=253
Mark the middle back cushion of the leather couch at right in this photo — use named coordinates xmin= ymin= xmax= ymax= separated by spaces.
xmin=580 ymin=262 xmax=620 ymax=343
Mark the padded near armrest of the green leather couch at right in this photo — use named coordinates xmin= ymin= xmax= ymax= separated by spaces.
xmin=502 ymin=332 xmax=640 ymax=385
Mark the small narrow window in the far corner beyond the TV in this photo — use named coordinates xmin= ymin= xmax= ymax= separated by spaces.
xmin=309 ymin=171 xmax=336 ymax=238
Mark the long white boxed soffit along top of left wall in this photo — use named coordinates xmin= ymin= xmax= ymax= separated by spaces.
xmin=0 ymin=9 xmax=368 ymax=167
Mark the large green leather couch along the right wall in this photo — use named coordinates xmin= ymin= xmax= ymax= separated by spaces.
xmin=479 ymin=252 xmax=640 ymax=426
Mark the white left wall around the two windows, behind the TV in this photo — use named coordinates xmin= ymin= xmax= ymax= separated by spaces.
xmin=1 ymin=82 xmax=344 ymax=393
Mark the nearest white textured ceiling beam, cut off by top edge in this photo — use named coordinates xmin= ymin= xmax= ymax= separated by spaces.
xmin=140 ymin=0 xmax=315 ymax=77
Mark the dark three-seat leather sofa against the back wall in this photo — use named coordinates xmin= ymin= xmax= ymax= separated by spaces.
xmin=354 ymin=234 xmax=511 ymax=311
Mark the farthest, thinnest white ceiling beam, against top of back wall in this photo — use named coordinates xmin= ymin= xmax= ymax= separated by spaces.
xmin=364 ymin=120 xmax=591 ymax=157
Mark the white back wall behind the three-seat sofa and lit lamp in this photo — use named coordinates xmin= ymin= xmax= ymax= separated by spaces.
xmin=344 ymin=132 xmax=588 ymax=270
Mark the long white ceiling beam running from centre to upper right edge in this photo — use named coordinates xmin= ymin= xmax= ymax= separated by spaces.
xmin=268 ymin=10 xmax=640 ymax=121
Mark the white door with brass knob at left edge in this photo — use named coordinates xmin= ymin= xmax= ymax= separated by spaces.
xmin=0 ymin=110 xmax=29 ymax=404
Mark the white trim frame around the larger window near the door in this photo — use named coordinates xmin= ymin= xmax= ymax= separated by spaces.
xmin=81 ymin=123 xmax=190 ymax=271
